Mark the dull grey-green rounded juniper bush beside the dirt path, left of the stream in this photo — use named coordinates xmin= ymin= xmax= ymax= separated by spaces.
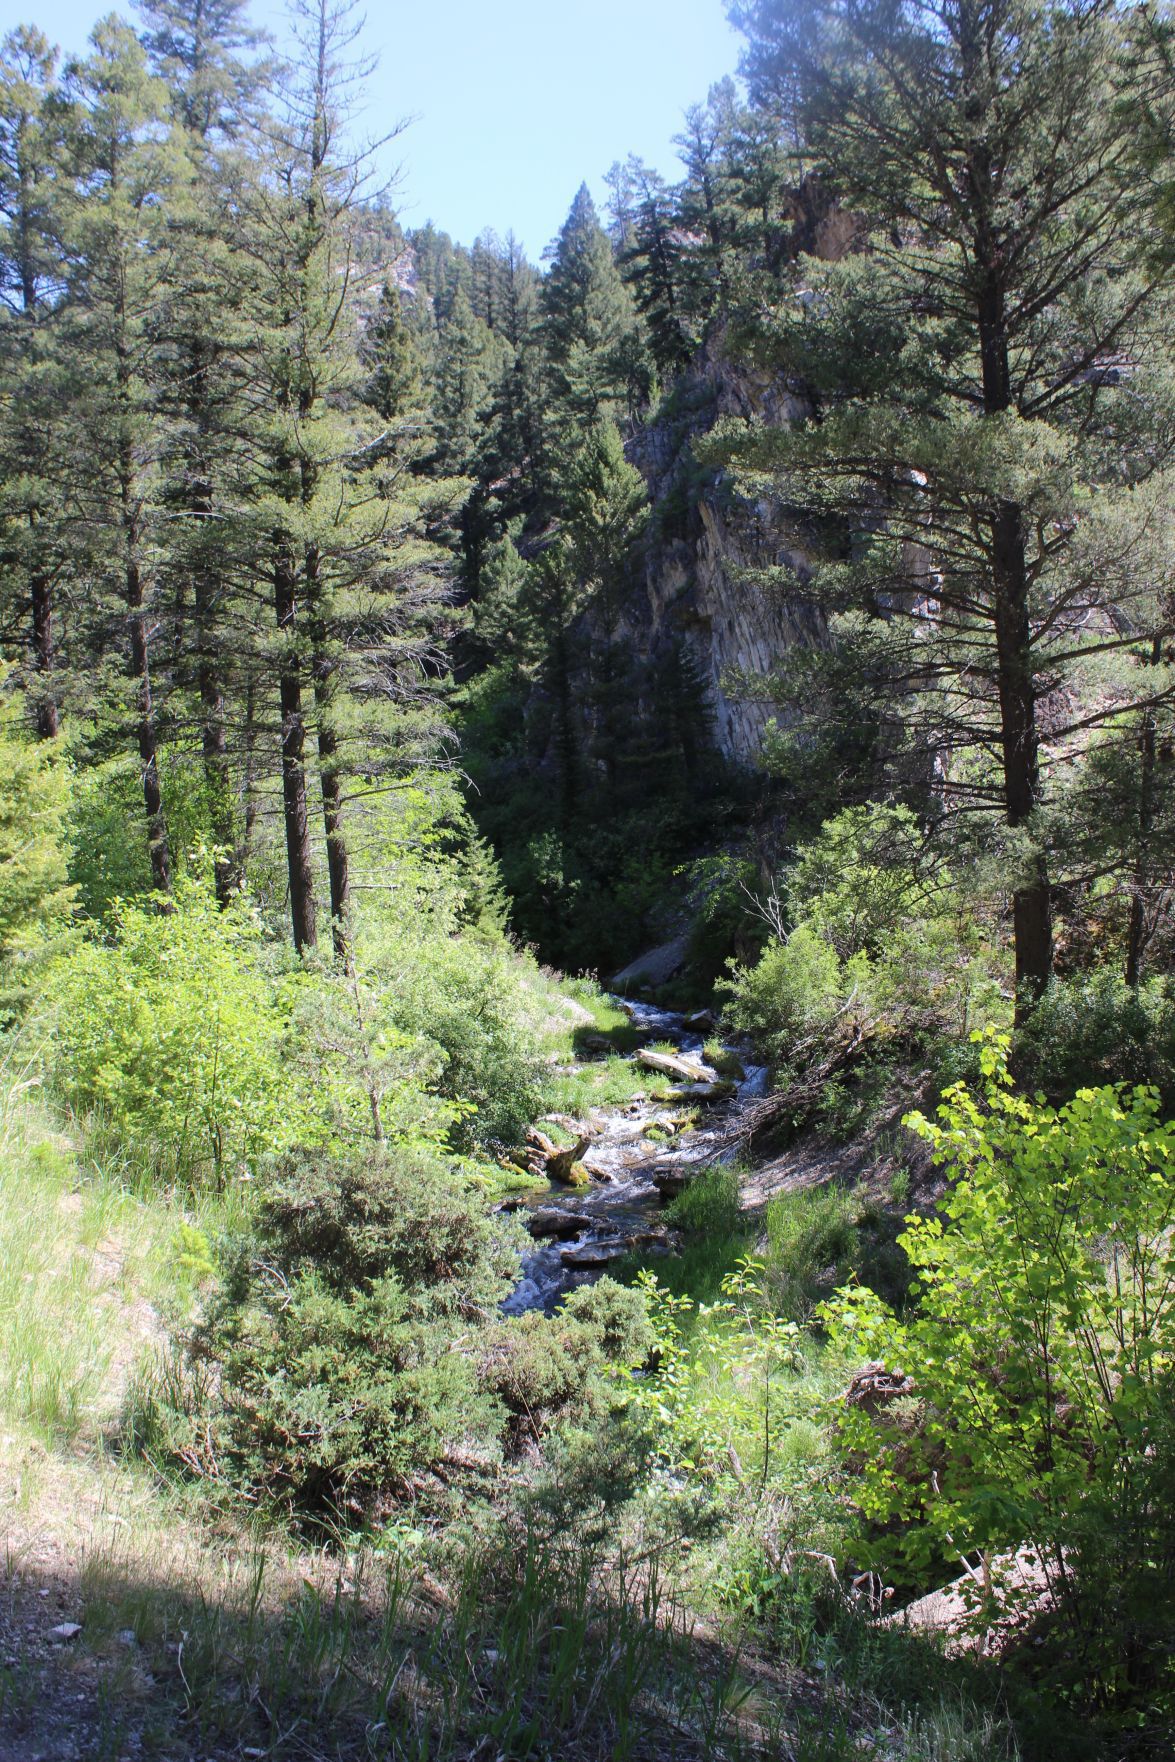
xmin=170 ymin=1147 xmax=518 ymax=1515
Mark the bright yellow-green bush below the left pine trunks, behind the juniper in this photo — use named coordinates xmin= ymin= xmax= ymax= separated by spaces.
xmin=41 ymin=879 xmax=305 ymax=1182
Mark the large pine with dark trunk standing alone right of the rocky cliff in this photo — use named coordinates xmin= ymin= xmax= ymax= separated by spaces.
xmin=729 ymin=0 xmax=1171 ymax=1018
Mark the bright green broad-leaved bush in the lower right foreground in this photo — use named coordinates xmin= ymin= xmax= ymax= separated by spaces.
xmin=826 ymin=1033 xmax=1175 ymax=1691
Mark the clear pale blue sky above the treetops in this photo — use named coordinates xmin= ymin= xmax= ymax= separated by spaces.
xmin=9 ymin=0 xmax=740 ymax=263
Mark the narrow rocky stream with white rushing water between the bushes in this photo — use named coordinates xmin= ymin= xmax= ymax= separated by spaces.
xmin=502 ymin=997 xmax=768 ymax=1314
